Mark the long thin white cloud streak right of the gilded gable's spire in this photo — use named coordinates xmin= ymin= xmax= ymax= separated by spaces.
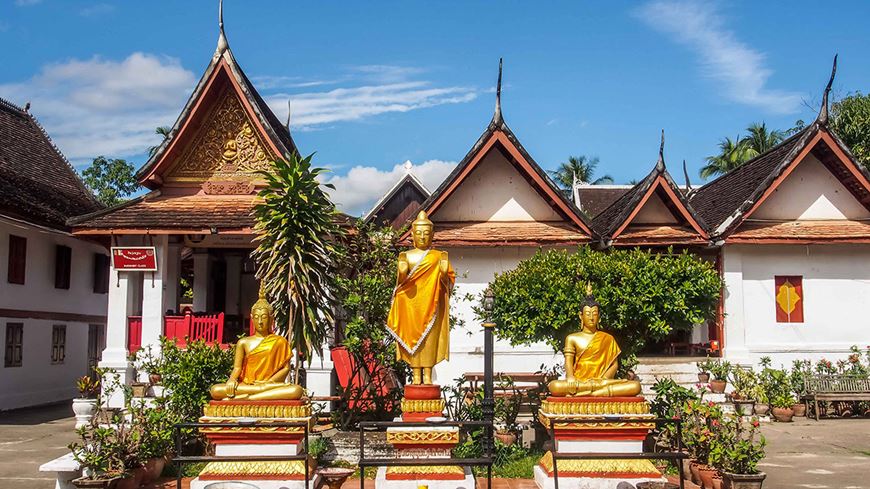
xmin=266 ymin=81 xmax=477 ymax=129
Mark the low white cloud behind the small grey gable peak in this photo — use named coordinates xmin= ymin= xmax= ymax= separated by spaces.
xmin=325 ymin=160 xmax=456 ymax=216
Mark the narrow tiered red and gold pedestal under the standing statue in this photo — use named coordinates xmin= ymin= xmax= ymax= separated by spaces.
xmin=375 ymin=384 xmax=475 ymax=489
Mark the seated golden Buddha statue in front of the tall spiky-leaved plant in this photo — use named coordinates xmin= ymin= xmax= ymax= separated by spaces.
xmin=210 ymin=288 xmax=305 ymax=401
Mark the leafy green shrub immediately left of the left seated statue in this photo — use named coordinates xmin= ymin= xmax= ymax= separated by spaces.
xmin=161 ymin=338 xmax=233 ymax=422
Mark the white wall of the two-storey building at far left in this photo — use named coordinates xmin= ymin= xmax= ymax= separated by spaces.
xmin=0 ymin=218 xmax=108 ymax=410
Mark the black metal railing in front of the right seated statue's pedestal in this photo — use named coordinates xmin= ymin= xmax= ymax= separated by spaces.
xmin=547 ymin=416 xmax=689 ymax=489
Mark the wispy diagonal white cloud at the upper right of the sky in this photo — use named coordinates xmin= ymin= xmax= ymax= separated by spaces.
xmin=635 ymin=0 xmax=801 ymax=114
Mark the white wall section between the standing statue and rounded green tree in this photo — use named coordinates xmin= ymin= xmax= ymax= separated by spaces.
xmin=435 ymin=248 xmax=561 ymax=386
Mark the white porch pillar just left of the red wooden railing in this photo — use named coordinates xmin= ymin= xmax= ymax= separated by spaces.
xmin=142 ymin=234 xmax=169 ymax=353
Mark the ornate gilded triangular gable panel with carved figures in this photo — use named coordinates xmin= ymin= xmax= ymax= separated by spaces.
xmin=166 ymin=89 xmax=275 ymax=182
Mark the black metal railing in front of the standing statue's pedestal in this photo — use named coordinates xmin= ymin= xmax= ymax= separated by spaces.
xmin=359 ymin=421 xmax=494 ymax=489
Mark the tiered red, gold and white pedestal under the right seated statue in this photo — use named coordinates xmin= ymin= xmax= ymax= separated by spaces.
xmin=535 ymin=396 xmax=665 ymax=489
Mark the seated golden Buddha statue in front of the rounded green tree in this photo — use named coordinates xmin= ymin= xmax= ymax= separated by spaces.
xmin=549 ymin=285 xmax=640 ymax=397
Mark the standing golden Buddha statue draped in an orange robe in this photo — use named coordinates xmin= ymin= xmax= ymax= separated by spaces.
xmin=387 ymin=211 xmax=456 ymax=384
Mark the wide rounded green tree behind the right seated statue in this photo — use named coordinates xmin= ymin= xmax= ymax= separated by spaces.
xmin=484 ymin=246 xmax=722 ymax=368
